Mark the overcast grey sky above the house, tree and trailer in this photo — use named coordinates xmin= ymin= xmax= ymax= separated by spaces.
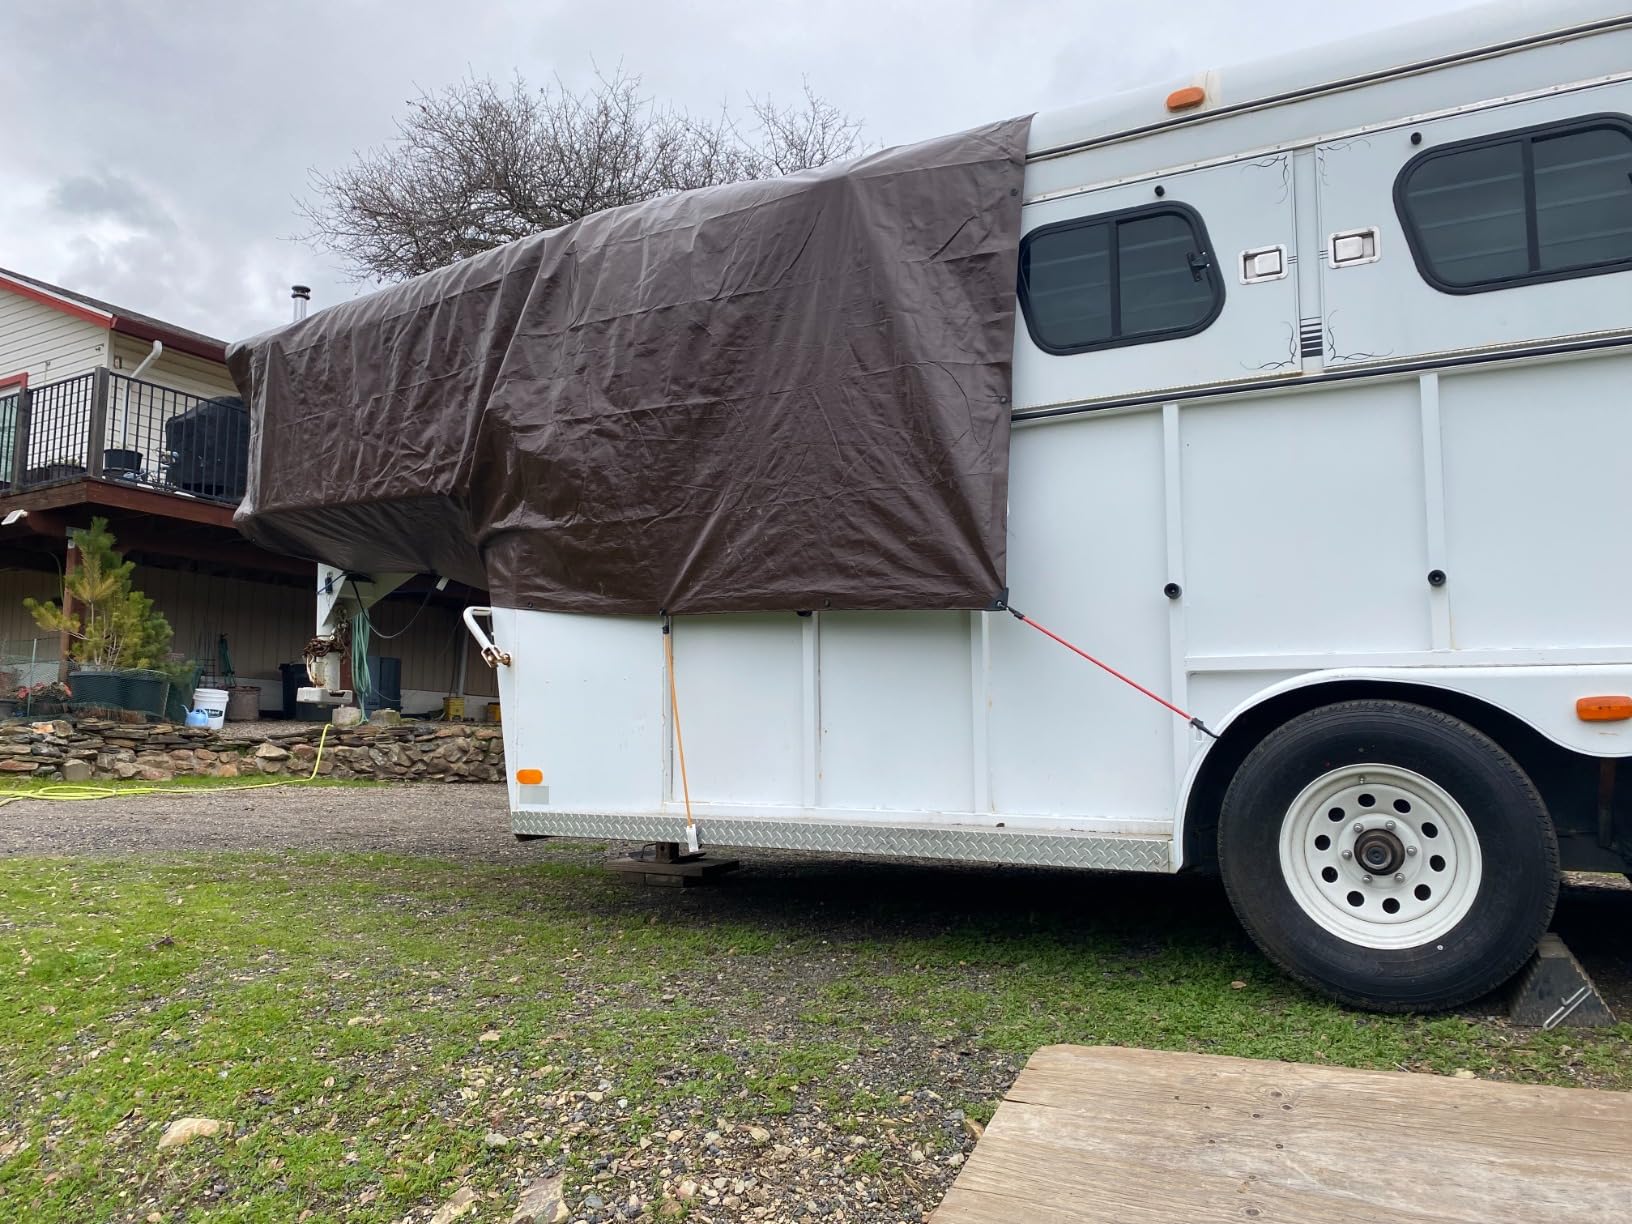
xmin=0 ymin=0 xmax=1466 ymax=339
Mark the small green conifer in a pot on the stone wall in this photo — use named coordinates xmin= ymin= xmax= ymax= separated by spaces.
xmin=23 ymin=517 xmax=171 ymax=715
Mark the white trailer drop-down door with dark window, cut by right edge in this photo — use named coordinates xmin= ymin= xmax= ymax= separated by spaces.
xmin=1314 ymin=82 xmax=1632 ymax=369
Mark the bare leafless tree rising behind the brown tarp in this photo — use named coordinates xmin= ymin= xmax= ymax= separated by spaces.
xmin=297 ymin=70 xmax=863 ymax=281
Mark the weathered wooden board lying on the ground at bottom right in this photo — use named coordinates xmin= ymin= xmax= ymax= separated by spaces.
xmin=932 ymin=1046 xmax=1632 ymax=1224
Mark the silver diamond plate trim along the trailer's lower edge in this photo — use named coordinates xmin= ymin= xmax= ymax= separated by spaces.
xmin=511 ymin=811 xmax=1172 ymax=871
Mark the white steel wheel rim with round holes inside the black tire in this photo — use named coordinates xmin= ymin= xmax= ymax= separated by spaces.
xmin=1281 ymin=765 xmax=1483 ymax=948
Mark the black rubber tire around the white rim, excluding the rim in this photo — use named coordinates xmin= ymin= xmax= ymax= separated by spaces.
xmin=1217 ymin=700 xmax=1559 ymax=1012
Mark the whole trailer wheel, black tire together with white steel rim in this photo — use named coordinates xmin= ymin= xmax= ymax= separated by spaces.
xmin=1219 ymin=700 xmax=1559 ymax=1012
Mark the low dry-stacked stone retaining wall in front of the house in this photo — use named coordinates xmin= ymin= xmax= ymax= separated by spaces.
xmin=0 ymin=718 xmax=504 ymax=782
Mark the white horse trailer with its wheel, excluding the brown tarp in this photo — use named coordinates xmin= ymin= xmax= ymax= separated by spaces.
xmin=440 ymin=2 xmax=1632 ymax=1009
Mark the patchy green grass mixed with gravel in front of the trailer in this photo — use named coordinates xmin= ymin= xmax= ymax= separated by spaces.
xmin=0 ymin=842 xmax=1632 ymax=1224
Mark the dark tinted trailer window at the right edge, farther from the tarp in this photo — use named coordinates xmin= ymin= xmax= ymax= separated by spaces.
xmin=1394 ymin=116 xmax=1632 ymax=294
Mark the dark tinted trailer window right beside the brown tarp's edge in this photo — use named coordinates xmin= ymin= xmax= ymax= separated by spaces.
xmin=1020 ymin=204 xmax=1224 ymax=353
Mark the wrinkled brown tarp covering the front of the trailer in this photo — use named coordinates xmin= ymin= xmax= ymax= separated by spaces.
xmin=227 ymin=119 xmax=1030 ymax=614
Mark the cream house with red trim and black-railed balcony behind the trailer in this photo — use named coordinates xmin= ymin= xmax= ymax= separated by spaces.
xmin=0 ymin=269 xmax=498 ymax=713
